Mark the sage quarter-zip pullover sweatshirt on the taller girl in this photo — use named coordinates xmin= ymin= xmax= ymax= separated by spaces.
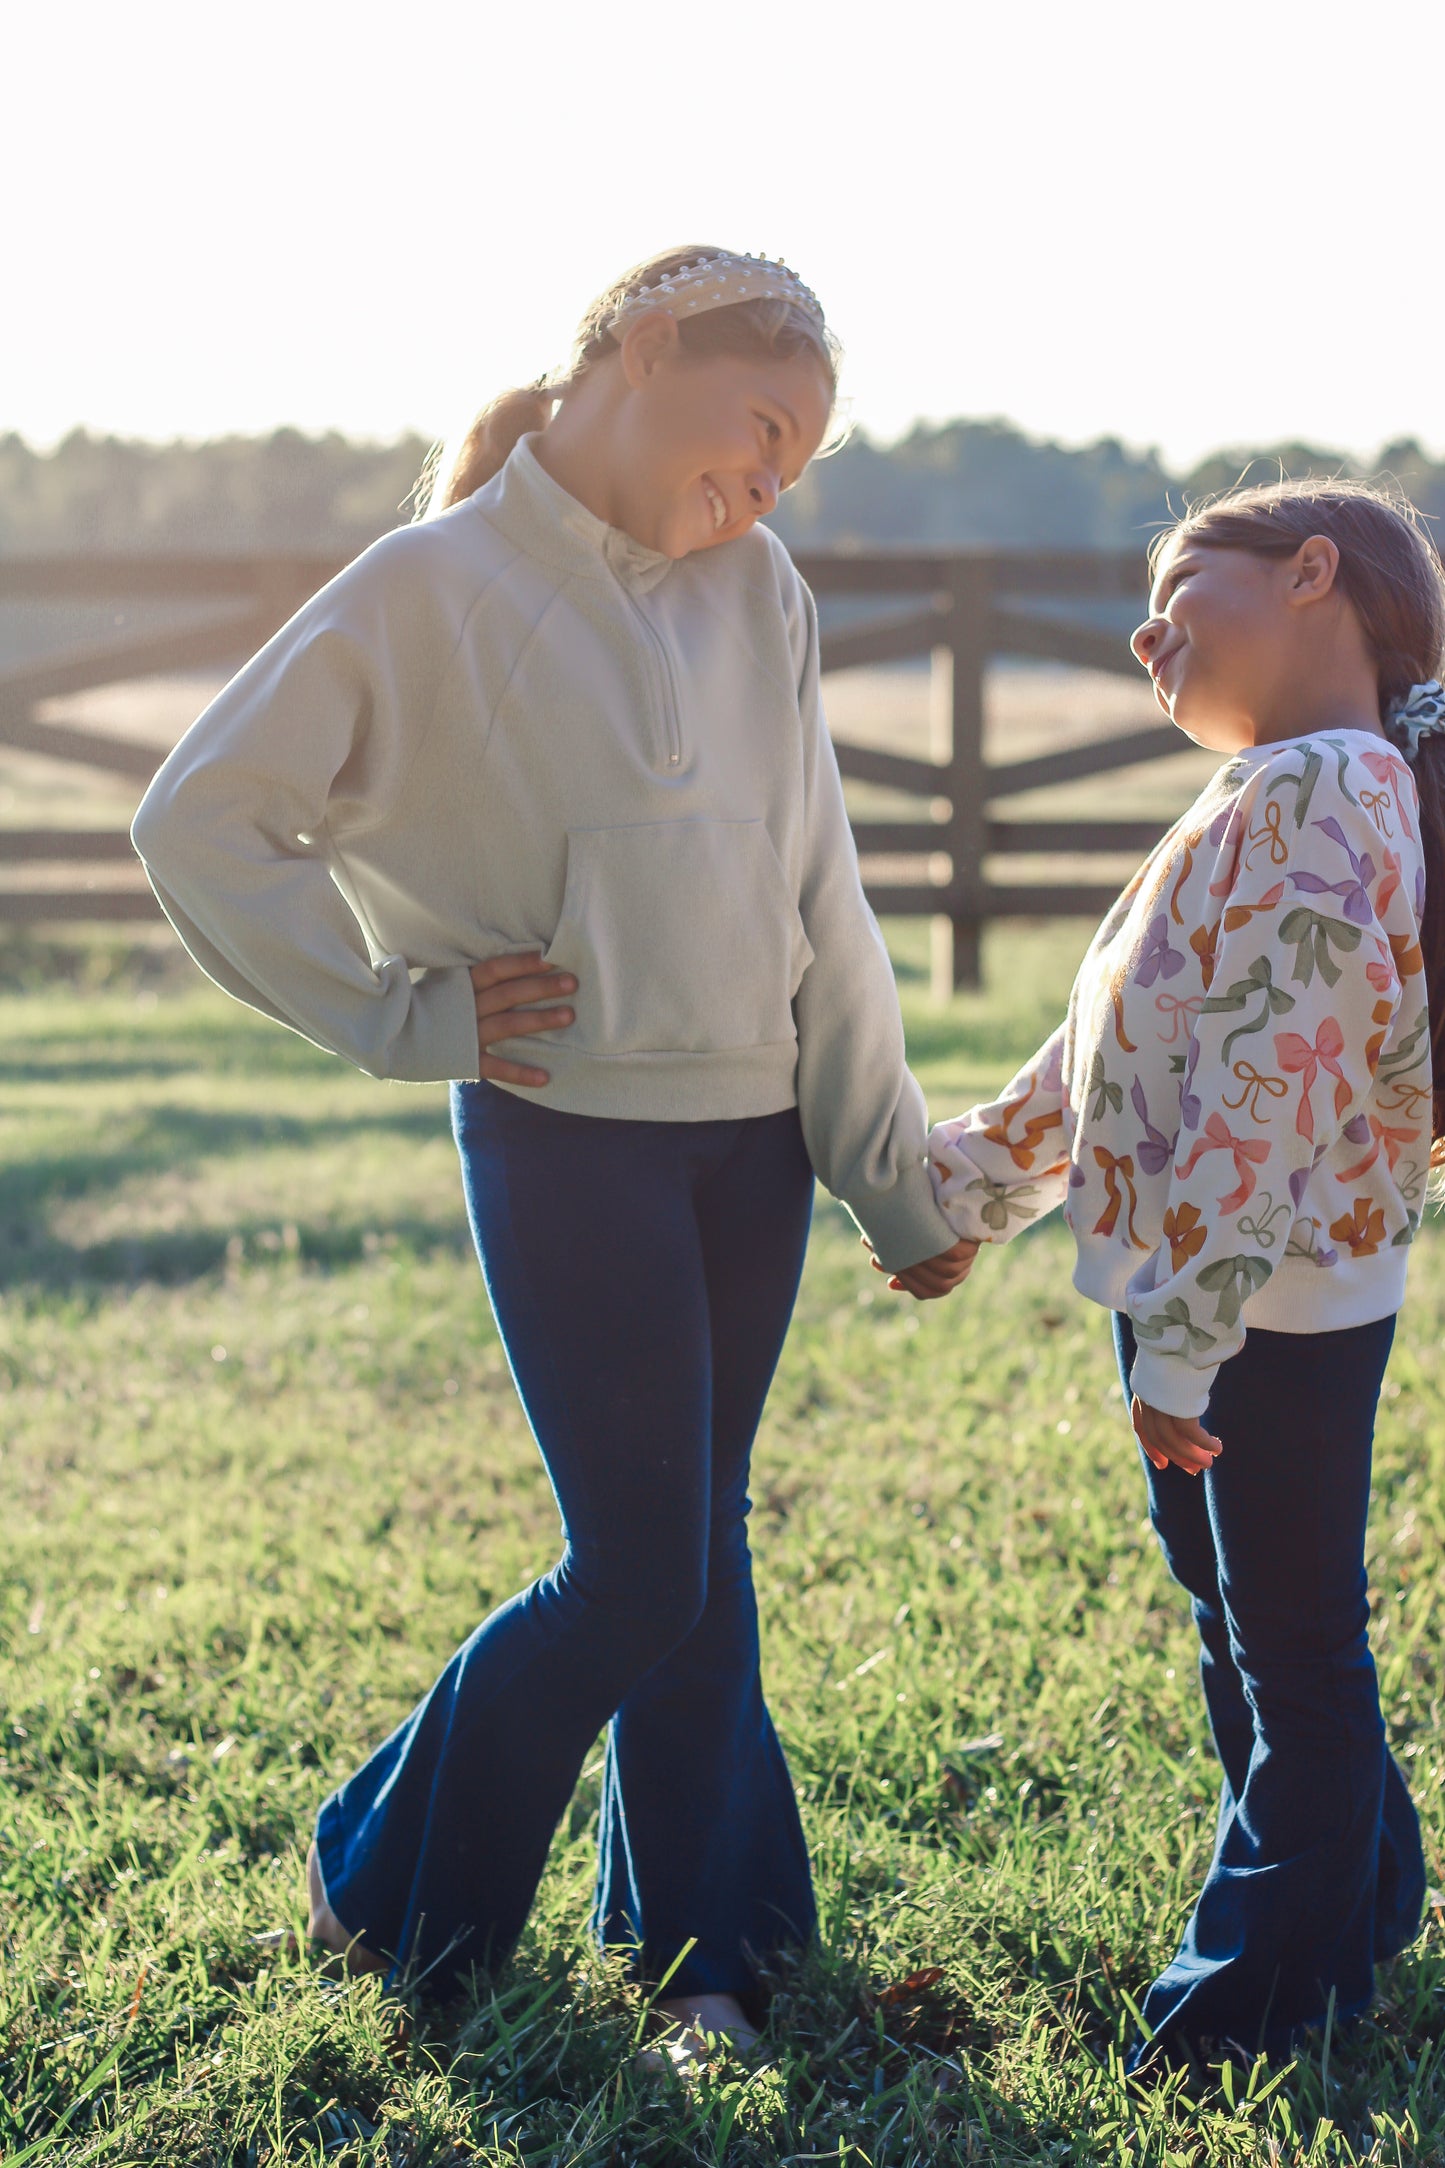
xmin=132 ymin=438 xmax=953 ymax=1268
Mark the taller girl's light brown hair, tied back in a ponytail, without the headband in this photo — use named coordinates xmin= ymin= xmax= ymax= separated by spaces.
xmin=414 ymin=247 xmax=838 ymax=520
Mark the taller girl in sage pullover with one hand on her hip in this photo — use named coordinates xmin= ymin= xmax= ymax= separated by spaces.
xmin=134 ymin=249 xmax=962 ymax=2034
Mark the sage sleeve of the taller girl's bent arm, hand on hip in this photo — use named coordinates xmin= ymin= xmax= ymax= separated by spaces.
xmin=132 ymin=531 xmax=479 ymax=1082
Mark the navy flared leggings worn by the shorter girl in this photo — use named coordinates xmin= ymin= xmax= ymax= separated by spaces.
xmin=1114 ymin=1316 xmax=1426 ymax=2062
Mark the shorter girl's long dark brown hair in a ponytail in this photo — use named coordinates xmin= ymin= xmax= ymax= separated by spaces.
xmin=1150 ymin=479 xmax=1445 ymax=1166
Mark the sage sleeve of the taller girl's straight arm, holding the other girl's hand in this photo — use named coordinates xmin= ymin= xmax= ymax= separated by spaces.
xmin=779 ymin=581 xmax=958 ymax=1270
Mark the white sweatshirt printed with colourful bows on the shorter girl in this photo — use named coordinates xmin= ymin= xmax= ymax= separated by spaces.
xmin=929 ymin=731 xmax=1432 ymax=1416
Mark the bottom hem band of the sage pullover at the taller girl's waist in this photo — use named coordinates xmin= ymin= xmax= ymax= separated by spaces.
xmin=492 ymin=1038 xmax=797 ymax=1121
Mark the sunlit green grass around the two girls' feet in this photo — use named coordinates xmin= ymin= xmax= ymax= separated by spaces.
xmin=0 ymin=928 xmax=1445 ymax=2168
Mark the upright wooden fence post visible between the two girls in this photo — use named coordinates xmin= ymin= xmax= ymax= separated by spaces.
xmin=932 ymin=555 xmax=992 ymax=999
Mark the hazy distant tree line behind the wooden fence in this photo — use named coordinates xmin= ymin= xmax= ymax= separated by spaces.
xmin=0 ymin=421 xmax=1445 ymax=557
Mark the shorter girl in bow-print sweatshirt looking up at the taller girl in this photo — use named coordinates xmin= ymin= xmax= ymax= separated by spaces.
xmin=922 ymin=483 xmax=1445 ymax=2060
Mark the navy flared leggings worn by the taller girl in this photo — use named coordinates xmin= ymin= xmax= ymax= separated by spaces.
xmin=316 ymin=1084 xmax=815 ymax=1999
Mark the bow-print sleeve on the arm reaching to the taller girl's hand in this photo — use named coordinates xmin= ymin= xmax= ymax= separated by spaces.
xmin=929 ymin=1023 xmax=1070 ymax=1242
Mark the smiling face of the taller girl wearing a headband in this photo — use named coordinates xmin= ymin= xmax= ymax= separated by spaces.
xmin=613 ymin=310 xmax=834 ymax=557
